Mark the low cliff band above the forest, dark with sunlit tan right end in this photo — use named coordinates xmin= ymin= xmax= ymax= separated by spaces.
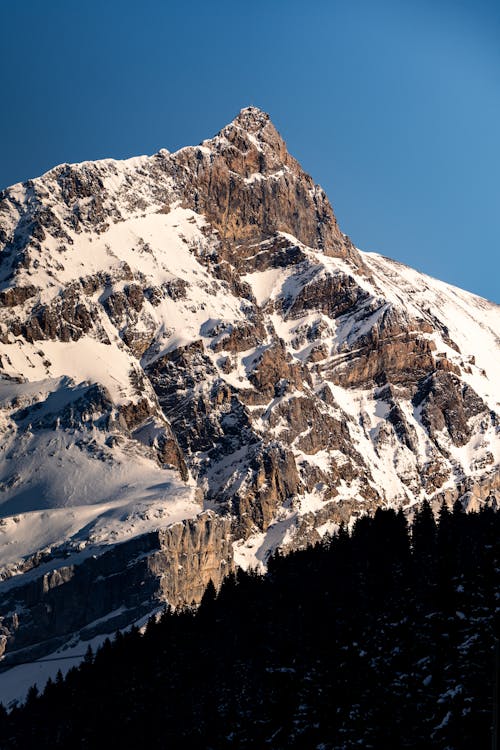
xmin=0 ymin=512 xmax=230 ymax=666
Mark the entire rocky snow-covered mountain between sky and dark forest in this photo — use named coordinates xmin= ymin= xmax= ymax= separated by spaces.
xmin=0 ymin=107 xmax=500 ymax=680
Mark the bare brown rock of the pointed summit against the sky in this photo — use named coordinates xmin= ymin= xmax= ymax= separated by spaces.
xmin=172 ymin=107 xmax=351 ymax=257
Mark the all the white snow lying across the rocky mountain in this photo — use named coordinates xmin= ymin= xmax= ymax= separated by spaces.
xmin=0 ymin=123 xmax=500 ymax=628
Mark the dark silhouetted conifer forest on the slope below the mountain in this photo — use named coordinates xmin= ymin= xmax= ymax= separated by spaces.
xmin=0 ymin=503 xmax=500 ymax=750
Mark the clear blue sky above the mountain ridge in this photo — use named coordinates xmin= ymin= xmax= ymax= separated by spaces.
xmin=0 ymin=0 xmax=500 ymax=302
